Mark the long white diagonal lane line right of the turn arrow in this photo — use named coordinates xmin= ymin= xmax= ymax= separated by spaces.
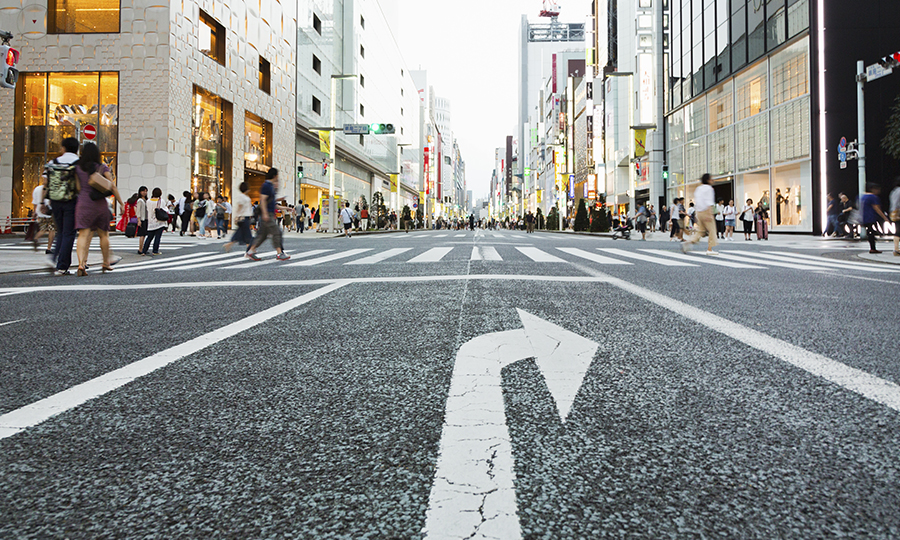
xmin=583 ymin=267 xmax=900 ymax=411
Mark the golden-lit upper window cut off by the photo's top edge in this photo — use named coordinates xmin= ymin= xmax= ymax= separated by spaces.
xmin=47 ymin=0 xmax=120 ymax=34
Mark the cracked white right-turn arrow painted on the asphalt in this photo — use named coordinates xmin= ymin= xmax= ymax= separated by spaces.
xmin=424 ymin=310 xmax=599 ymax=540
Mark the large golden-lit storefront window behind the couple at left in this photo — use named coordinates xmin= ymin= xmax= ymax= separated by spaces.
xmin=13 ymin=72 xmax=119 ymax=217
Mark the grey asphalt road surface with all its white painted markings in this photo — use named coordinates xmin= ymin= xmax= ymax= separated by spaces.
xmin=0 ymin=231 xmax=900 ymax=539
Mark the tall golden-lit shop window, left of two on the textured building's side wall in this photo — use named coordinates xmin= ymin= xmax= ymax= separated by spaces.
xmin=191 ymin=86 xmax=232 ymax=202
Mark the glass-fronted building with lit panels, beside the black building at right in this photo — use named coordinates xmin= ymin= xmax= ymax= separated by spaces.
xmin=667 ymin=0 xmax=814 ymax=232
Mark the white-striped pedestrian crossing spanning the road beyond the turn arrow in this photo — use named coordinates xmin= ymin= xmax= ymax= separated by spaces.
xmin=102 ymin=245 xmax=900 ymax=274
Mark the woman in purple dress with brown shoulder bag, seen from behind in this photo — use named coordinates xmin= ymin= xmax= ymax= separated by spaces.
xmin=75 ymin=142 xmax=124 ymax=276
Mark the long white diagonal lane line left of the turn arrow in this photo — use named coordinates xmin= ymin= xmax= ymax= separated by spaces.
xmin=0 ymin=282 xmax=346 ymax=439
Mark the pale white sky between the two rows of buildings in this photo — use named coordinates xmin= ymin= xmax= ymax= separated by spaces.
xmin=396 ymin=0 xmax=591 ymax=198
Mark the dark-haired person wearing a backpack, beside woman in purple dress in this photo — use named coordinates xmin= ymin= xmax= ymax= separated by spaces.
xmin=43 ymin=137 xmax=79 ymax=276
